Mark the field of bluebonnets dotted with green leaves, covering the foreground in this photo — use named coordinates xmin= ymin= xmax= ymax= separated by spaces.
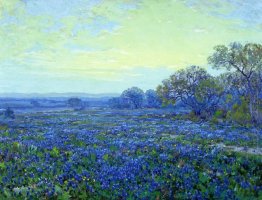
xmin=0 ymin=109 xmax=262 ymax=200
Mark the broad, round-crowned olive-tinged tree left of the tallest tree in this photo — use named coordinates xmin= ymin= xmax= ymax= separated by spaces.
xmin=157 ymin=66 xmax=223 ymax=115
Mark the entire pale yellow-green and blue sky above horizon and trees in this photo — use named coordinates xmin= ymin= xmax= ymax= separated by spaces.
xmin=0 ymin=0 xmax=262 ymax=94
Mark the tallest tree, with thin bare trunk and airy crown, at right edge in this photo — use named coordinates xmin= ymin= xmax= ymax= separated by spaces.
xmin=208 ymin=42 xmax=262 ymax=121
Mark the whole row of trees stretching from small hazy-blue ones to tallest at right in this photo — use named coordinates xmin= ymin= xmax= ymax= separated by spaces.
xmin=109 ymin=42 xmax=262 ymax=124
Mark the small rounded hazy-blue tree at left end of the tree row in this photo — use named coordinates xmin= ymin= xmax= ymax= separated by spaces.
xmin=121 ymin=87 xmax=145 ymax=109
